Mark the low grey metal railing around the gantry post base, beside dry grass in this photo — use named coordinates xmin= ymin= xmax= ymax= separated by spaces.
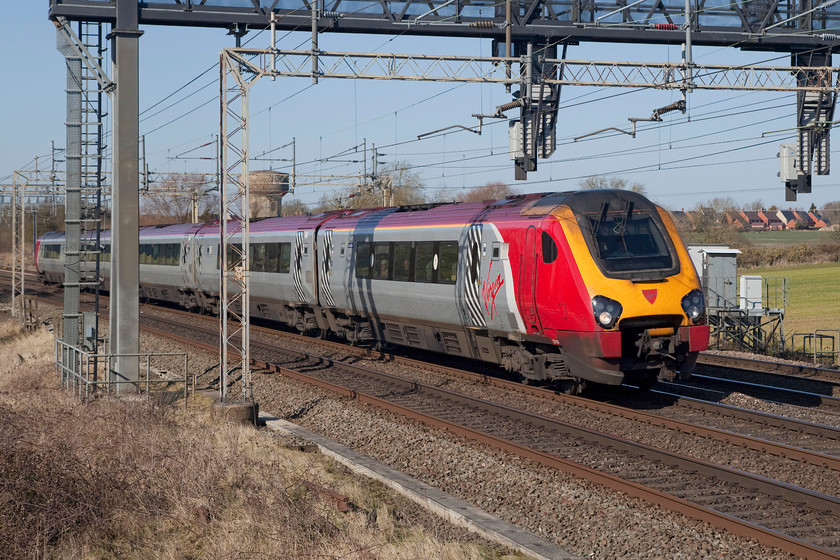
xmin=55 ymin=339 xmax=196 ymax=407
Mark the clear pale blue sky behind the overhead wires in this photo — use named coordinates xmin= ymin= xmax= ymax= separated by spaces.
xmin=0 ymin=0 xmax=840 ymax=209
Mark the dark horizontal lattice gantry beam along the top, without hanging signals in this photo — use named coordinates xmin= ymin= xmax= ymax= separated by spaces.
xmin=44 ymin=0 xmax=840 ymax=52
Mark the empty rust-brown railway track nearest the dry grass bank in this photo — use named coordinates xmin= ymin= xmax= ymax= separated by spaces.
xmin=138 ymin=310 xmax=840 ymax=558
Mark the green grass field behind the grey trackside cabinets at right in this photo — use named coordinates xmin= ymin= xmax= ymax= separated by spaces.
xmin=738 ymin=263 xmax=840 ymax=340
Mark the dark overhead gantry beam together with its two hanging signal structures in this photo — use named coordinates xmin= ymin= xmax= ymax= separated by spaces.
xmin=50 ymin=0 xmax=840 ymax=189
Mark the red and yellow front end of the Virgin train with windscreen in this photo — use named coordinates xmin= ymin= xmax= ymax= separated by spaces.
xmin=472 ymin=190 xmax=709 ymax=391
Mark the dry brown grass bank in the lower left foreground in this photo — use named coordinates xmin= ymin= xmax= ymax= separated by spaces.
xmin=0 ymin=322 xmax=520 ymax=560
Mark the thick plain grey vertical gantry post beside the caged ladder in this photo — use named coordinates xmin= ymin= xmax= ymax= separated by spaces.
xmin=109 ymin=0 xmax=142 ymax=391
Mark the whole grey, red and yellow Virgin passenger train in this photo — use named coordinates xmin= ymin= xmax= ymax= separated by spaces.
xmin=36 ymin=189 xmax=709 ymax=394
